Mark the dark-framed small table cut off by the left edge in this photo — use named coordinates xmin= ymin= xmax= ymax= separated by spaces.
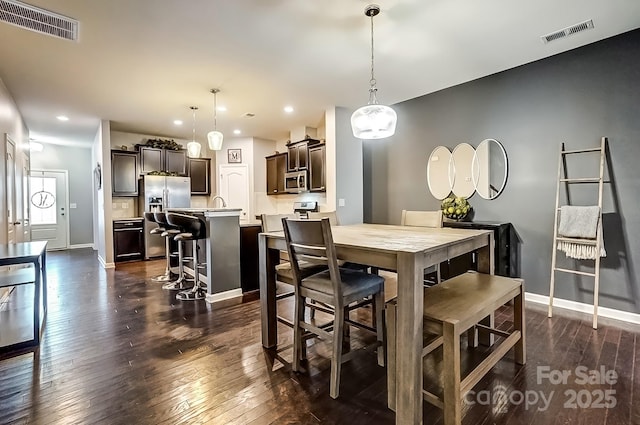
xmin=0 ymin=241 xmax=47 ymax=354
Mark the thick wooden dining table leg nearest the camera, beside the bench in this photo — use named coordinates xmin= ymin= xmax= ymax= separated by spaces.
xmin=396 ymin=252 xmax=424 ymax=425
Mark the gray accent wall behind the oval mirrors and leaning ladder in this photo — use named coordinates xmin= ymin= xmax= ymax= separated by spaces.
xmin=363 ymin=30 xmax=640 ymax=313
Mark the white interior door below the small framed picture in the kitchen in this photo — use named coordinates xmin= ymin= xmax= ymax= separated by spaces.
xmin=216 ymin=164 xmax=250 ymax=220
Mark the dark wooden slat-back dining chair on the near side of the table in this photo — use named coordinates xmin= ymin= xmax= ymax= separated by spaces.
xmin=282 ymin=218 xmax=384 ymax=398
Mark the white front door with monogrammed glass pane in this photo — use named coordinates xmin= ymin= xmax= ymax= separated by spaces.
xmin=29 ymin=170 xmax=69 ymax=249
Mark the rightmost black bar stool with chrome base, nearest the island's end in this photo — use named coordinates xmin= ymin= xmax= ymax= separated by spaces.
xmin=166 ymin=213 xmax=207 ymax=301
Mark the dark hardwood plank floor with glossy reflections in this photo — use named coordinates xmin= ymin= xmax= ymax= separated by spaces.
xmin=0 ymin=249 xmax=640 ymax=425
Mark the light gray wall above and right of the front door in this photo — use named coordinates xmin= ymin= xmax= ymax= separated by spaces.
xmin=31 ymin=144 xmax=95 ymax=245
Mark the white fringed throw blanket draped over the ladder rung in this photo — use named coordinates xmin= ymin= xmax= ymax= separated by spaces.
xmin=557 ymin=205 xmax=607 ymax=260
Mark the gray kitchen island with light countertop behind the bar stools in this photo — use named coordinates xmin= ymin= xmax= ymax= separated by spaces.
xmin=167 ymin=208 xmax=242 ymax=303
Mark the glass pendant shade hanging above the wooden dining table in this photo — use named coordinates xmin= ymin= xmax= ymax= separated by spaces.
xmin=351 ymin=104 xmax=398 ymax=140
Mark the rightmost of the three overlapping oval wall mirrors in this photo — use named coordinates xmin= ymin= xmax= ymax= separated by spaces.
xmin=473 ymin=139 xmax=508 ymax=199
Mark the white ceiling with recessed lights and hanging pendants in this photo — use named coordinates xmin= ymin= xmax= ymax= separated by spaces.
xmin=0 ymin=0 xmax=640 ymax=145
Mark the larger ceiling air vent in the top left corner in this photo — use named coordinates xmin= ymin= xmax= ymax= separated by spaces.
xmin=0 ymin=0 xmax=78 ymax=41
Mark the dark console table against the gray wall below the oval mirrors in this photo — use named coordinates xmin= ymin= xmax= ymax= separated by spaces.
xmin=440 ymin=221 xmax=520 ymax=279
